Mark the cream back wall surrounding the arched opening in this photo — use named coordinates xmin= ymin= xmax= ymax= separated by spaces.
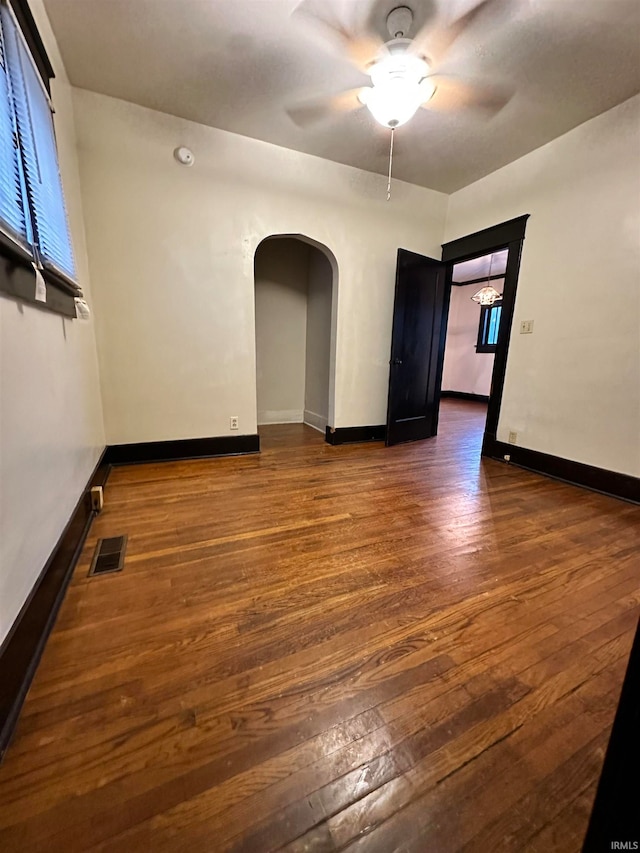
xmin=74 ymin=90 xmax=447 ymax=443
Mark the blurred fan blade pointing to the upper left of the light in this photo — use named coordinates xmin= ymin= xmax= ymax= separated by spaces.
xmin=292 ymin=0 xmax=383 ymax=71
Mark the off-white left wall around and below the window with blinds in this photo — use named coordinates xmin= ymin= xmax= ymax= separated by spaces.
xmin=0 ymin=0 xmax=104 ymax=642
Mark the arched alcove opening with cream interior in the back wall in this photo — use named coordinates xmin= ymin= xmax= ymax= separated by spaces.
xmin=254 ymin=234 xmax=338 ymax=434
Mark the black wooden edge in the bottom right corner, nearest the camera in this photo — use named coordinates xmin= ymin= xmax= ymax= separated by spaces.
xmin=582 ymin=623 xmax=640 ymax=853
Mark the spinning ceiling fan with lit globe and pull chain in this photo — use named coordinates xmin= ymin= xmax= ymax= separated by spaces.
xmin=287 ymin=0 xmax=513 ymax=197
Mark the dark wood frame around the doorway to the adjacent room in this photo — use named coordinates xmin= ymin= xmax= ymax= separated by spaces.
xmin=440 ymin=213 xmax=530 ymax=458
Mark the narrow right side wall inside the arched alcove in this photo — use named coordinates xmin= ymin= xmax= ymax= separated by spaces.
xmin=304 ymin=249 xmax=333 ymax=432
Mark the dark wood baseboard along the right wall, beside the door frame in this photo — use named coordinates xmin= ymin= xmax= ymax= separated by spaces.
xmin=482 ymin=433 xmax=640 ymax=504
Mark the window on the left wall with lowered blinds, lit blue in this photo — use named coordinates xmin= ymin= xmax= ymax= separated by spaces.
xmin=0 ymin=0 xmax=80 ymax=313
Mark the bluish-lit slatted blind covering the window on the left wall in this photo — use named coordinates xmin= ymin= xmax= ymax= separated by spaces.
xmin=0 ymin=2 xmax=76 ymax=282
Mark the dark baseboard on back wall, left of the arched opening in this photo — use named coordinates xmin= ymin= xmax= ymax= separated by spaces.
xmin=105 ymin=435 xmax=260 ymax=465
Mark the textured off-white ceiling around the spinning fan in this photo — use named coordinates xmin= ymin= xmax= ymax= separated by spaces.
xmin=45 ymin=0 xmax=640 ymax=192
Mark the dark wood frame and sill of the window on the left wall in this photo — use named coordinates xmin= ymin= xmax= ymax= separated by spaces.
xmin=0 ymin=0 xmax=82 ymax=318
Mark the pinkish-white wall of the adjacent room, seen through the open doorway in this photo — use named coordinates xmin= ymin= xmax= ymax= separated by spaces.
xmin=442 ymin=281 xmax=502 ymax=395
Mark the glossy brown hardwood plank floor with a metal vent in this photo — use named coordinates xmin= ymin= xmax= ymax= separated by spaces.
xmin=0 ymin=401 xmax=640 ymax=853
